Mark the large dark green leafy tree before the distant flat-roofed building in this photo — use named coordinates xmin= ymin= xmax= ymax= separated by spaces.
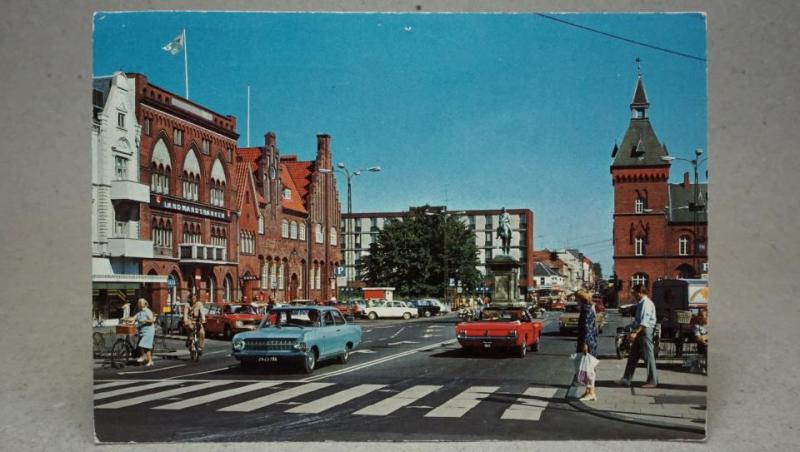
xmin=360 ymin=206 xmax=483 ymax=297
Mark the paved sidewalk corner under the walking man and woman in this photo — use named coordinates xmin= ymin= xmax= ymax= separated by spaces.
xmin=567 ymin=355 xmax=708 ymax=433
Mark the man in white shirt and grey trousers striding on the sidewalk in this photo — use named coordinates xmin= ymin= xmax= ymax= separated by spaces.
xmin=619 ymin=284 xmax=658 ymax=388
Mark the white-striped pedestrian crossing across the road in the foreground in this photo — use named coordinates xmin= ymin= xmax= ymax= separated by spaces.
xmin=94 ymin=380 xmax=565 ymax=422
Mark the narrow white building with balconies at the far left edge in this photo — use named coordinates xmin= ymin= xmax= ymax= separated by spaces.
xmin=92 ymin=72 xmax=166 ymax=318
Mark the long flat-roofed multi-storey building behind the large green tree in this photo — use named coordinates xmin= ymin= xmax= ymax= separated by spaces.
xmin=338 ymin=207 xmax=533 ymax=294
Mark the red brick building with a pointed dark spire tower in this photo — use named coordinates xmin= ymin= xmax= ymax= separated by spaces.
xmin=611 ymin=76 xmax=708 ymax=299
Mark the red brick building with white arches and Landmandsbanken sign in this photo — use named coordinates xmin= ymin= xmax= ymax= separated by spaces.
xmin=128 ymin=74 xmax=239 ymax=312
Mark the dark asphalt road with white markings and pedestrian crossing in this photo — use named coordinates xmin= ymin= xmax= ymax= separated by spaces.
xmin=94 ymin=313 xmax=701 ymax=442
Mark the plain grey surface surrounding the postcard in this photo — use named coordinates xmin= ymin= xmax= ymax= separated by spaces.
xmin=0 ymin=0 xmax=800 ymax=451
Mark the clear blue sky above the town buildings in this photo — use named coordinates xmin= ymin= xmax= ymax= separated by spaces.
xmin=93 ymin=12 xmax=707 ymax=275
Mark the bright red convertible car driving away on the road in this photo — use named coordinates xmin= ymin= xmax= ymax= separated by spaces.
xmin=456 ymin=306 xmax=542 ymax=358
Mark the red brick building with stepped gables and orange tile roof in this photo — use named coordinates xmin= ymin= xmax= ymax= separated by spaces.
xmin=236 ymin=132 xmax=341 ymax=301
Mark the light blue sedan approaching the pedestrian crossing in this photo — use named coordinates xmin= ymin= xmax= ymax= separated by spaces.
xmin=232 ymin=306 xmax=361 ymax=373
